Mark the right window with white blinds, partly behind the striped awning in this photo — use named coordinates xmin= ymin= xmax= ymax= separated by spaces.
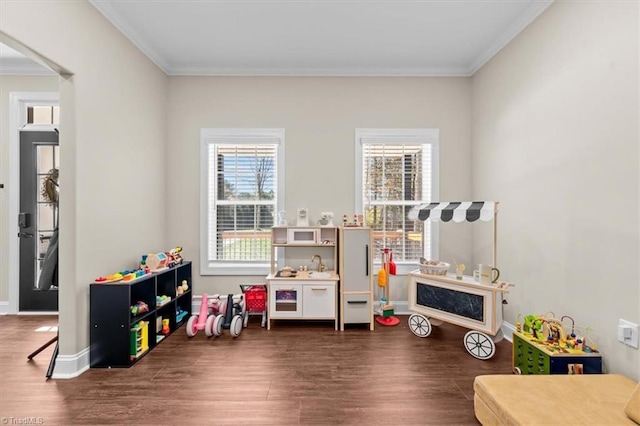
xmin=356 ymin=129 xmax=439 ymax=273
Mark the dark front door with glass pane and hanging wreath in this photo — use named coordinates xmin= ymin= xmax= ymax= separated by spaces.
xmin=17 ymin=126 xmax=60 ymax=312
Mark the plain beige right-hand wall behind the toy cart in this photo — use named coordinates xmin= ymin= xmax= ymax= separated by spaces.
xmin=472 ymin=1 xmax=640 ymax=380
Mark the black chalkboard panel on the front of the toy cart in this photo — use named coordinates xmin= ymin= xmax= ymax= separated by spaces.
xmin=416 ymin=283 xmax=484 ymax=322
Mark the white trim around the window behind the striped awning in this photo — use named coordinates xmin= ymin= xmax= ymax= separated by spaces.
xmin=355 ymin=129 xmax=440 ymax=275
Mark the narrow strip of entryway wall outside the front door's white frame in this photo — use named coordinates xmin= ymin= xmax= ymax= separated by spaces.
xmin=0 ymin=75 xmax=58 ymax=302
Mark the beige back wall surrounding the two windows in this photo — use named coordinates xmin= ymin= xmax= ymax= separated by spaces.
xmin=166 ymin=77 xmax=471 ymax=300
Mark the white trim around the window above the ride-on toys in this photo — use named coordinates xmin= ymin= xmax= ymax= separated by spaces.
xmin=200 ymin=128 xmax=285 ymax=276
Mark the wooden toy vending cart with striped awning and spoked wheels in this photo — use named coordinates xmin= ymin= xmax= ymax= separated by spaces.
xmin=408 ymin=201 xmax=513 ymax=360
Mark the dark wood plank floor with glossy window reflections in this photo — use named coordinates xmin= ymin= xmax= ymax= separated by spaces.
xmin=0 ymin=316 xmax=511 ymax=425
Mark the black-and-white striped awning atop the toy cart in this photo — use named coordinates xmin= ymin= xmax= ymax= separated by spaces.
xmin=408 ymin=201 xmax=497 ymax=222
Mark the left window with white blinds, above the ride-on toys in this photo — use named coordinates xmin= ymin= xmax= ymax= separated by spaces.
xmin=200 ymin=129 xmax=284 ymax=275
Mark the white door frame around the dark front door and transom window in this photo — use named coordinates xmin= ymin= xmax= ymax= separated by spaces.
xmin=7 ymin=92 xmax=60 ymax=314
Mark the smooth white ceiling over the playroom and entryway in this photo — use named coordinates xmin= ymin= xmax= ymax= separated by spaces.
xmin=0 ymin=0 xmax=553 ymax=76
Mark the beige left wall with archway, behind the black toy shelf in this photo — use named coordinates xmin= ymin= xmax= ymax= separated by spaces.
xmin=0 ymin=1 xmax=167 ymax=355
